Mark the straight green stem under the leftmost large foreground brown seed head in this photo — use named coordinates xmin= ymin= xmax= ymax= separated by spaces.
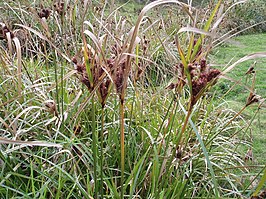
xmin=91 ymin=96 xmax=98 ymax=199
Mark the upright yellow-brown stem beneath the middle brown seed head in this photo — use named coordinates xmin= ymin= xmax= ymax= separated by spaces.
xmin=120 ymin=101 xmax=125 ymax=199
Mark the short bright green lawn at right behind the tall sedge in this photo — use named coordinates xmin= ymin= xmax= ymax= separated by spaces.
xmin=213 ymin=34 xmax=266 ymax=164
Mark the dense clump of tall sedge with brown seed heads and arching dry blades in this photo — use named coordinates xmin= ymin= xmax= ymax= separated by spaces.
xmin=0 ymin=0 xmax=266 ymax=198
